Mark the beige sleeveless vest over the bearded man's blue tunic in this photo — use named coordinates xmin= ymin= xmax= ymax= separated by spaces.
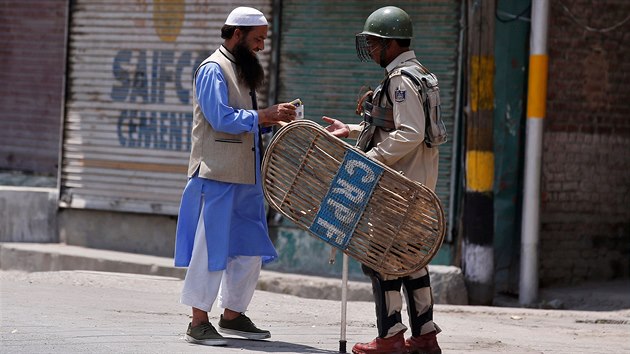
xmin=188 ymin=46 xmax=256 ymax=184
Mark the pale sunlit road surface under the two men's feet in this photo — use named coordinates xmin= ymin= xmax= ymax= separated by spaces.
xmin=0 ymin=271 xmax=630 ymax=354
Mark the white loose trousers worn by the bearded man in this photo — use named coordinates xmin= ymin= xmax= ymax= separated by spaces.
xmin=180 ymin=210 xmax=262 ymax=313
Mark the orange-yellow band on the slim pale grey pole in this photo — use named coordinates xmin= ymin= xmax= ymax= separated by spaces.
xmin=527 ymin=54 xmax=549 ymax=118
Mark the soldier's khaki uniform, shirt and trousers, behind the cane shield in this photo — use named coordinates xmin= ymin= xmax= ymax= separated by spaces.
xmin=348 ymin=51 xmax=440 ymax=337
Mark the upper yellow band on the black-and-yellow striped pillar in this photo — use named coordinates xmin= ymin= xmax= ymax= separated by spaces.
xmin=470 ymin=55 xmax=494 ymax=112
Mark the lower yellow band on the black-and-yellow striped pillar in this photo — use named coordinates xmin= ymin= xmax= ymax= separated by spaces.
xmin=466 ymin=150 xmax=494 ymax=192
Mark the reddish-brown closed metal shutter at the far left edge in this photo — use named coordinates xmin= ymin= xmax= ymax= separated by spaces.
xmin=0 ymin=0 xmax=68 ymax=176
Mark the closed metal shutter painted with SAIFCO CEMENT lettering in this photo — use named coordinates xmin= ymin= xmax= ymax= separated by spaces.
xmin=60 ymin=0 xmax=272 ymax=215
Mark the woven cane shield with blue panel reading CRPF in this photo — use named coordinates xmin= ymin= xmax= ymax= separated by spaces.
xmin=262 ymin=120 xmax=445 ymax=276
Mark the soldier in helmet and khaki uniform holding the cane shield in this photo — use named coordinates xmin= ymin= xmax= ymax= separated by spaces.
xmin=323 ymin=6 xmax=446 ymax=354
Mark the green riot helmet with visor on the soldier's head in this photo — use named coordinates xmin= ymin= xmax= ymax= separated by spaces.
xmin=356 ymin=6 xmax=413 ymax=62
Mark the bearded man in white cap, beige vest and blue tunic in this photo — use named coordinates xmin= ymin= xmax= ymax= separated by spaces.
xmin=175 ymin=7 xmax=295 ymax=345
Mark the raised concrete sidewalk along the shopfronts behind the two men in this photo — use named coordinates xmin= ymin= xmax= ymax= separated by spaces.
xmin=0 ymin=242 xmax=630 ymax=311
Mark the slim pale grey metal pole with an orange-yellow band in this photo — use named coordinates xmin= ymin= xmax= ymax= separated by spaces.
xmin=518 ymin=0 xmax=549 ymax=305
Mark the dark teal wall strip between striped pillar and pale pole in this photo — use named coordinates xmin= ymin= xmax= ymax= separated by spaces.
xmin=493 ymin=0 xmax=531 ymax=293
